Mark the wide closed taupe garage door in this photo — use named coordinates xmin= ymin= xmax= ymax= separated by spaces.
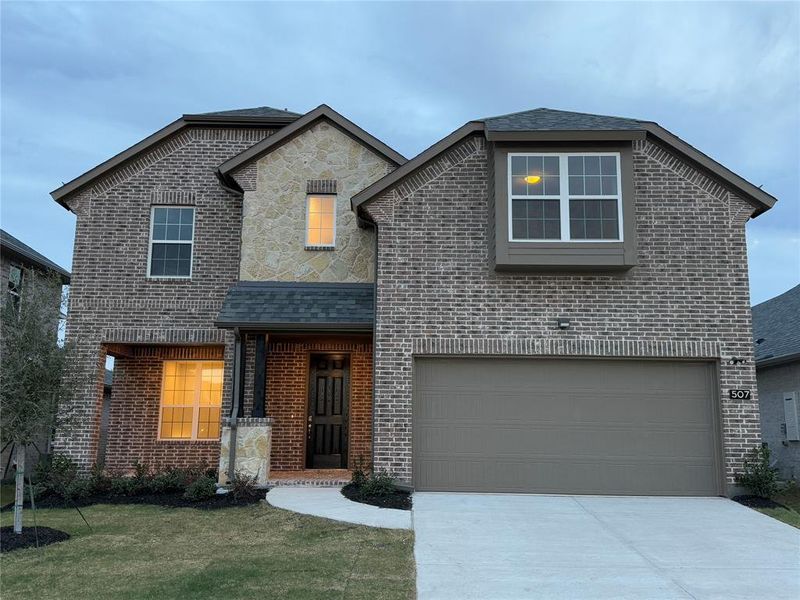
xmin=413 ymin=358 xmax=721 ymax=495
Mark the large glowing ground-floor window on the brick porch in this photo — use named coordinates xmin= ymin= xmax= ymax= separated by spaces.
xmin=159 ymin=361 xmax=223 ymax=440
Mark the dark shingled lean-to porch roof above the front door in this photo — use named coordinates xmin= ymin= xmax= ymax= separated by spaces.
xmin=215 ymin=281 xmax=375 ymax=331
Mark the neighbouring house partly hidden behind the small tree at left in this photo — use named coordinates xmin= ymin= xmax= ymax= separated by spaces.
xmin=0 ymin=229 xmax=70 ymax=478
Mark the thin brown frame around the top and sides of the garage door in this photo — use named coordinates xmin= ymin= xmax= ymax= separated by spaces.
xmin=410 ymin=354 xmax=728 ymax=497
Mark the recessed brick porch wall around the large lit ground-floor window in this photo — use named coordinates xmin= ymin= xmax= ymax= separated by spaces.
xmin=105 ymin=346 xmax=224 ymax=472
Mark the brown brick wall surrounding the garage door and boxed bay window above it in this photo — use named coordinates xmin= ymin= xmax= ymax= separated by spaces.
xmin=366 ymin=136 xmax=760 ymax=490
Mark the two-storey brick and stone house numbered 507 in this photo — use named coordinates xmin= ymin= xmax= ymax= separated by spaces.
xmin=52 ymin=105 xmax=775 ymax=495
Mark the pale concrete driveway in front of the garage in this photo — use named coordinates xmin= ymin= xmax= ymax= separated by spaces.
xmin=413 ymin=493 xmax=800 ymax=600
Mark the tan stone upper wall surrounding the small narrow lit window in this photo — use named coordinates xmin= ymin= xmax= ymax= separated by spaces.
xmin=237 ymin=121 xmax=393 ymax=282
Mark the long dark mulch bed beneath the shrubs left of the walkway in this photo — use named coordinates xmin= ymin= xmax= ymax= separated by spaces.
xmin=0 ymin=490 xmax=267 ymax=512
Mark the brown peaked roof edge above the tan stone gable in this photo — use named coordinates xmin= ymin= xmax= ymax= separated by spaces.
xmin=217 ymin=104 xmax=407 ymax=189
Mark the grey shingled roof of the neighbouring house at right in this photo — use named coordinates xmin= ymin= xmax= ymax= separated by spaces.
xmin=752 ymin=285 xmax=800 ymax=366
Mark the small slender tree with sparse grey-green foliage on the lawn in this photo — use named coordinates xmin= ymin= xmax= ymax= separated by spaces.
xmin=0 ymin=270 xmax=71 ymax=533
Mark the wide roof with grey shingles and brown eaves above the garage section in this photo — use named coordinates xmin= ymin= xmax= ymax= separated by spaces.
xmin=351 ymin=108 xmax=777 ymax=216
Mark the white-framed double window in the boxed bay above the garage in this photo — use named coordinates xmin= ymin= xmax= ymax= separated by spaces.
xmin=508 ymin=152 xmax=622 ymax=242
